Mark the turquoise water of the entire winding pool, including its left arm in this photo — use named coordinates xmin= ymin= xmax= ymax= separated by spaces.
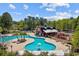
xmin=0 ymin=35 xmax=56 ymax=51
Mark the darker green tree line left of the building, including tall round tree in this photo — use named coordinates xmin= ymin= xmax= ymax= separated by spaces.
xmin=0 ymin=12 xmax=47 ymax=33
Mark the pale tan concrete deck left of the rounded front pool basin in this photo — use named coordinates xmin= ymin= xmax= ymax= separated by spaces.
xmin=7 ymin=38 xmax=34 ymax=52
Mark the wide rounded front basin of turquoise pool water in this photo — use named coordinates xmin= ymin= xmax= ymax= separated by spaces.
xmin=25 ymin=38 xmax=56 ymax=51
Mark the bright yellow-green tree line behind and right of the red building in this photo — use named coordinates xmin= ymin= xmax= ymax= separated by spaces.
xmin=48 ymin=16 xmax=79 ymax=31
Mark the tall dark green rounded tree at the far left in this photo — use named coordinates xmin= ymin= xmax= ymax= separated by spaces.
xmin=1 ymin=12 xmax=12 ymax=32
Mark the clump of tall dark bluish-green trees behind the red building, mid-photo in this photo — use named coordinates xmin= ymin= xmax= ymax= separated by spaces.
xmin=24 ymin=16 xmax=47 ymax=30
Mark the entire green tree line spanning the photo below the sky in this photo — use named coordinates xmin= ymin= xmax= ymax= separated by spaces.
xmin=0 ymin=12 xmax=79 ymax=32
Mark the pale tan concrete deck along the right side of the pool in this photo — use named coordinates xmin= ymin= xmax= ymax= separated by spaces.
xmin=45 ymin=38 xmax=69 ymax=53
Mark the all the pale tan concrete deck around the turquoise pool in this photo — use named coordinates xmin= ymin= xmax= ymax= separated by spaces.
xmin=7 ymin=33 xmax=68 ymax=55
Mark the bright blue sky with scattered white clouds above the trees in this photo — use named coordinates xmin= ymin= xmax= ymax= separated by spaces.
xmin=0 ymin=3 xmax=79 ymax=21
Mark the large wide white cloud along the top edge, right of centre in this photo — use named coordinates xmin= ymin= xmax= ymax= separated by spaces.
xmin=40 ymin=3 xmax=70 ymax=11
